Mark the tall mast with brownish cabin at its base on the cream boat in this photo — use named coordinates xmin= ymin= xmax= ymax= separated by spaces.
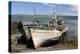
xmin=49 ymin=4 xmax=57 ymax=29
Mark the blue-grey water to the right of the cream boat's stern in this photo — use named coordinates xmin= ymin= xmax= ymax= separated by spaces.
xmin=65 ymin=20 xmax=78 ymax=36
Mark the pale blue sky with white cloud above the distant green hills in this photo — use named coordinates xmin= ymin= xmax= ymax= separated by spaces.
xmin=11 ymin=1 xmax=78 ymax=16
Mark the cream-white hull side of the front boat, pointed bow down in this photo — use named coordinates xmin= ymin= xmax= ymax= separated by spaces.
xmin=31 ymin=29 xmax=62 ymax=48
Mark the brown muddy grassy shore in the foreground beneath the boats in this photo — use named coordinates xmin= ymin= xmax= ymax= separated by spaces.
xmin=11 ymin=33 xmax=78 ymax=53
